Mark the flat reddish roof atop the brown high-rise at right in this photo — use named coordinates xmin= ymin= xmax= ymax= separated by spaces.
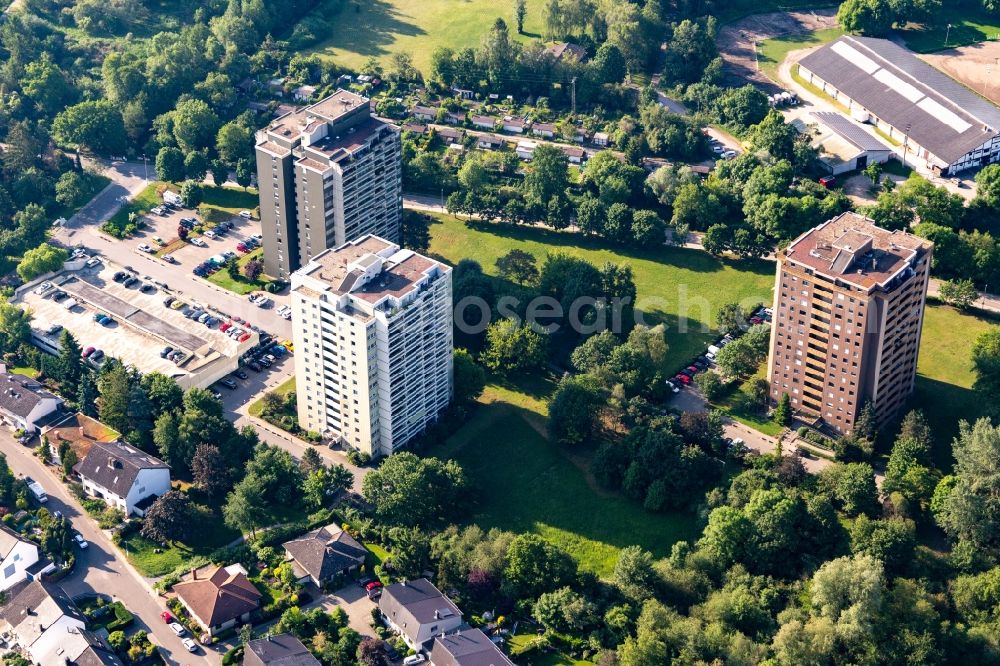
xmin=784 ymin=212 xmax=932 ymax=291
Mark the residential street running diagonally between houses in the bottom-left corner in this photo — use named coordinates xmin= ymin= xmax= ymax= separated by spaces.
xmin=0 ymin=429 xmax=211 ymax=665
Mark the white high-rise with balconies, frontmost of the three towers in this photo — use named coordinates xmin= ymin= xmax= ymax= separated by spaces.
xmin=291 ymin=235 xmax=452 ymax=457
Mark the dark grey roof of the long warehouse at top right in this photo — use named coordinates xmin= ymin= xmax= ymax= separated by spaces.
xmin=799 ymin=36 xmax=1000 ymax=164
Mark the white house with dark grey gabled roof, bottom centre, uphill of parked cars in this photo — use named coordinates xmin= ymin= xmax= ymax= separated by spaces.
xmin=378 ymin=578 xmax=462 ymax=650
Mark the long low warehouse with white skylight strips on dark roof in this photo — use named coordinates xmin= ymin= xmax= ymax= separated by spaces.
xmin=798 ymin=35 xmax=1000 ymax=175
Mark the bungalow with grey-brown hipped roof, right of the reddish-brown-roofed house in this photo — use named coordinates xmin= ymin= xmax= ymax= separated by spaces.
xmin=281 ymin=525 xmax=368 ymax=587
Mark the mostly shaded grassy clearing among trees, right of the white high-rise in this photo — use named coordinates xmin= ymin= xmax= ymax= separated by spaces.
xmin=431 ymin=379 xmax=697 ymax=576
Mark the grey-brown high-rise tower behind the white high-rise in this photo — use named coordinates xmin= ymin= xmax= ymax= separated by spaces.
xmin=256 ymin=90 xmax=403 ymax=279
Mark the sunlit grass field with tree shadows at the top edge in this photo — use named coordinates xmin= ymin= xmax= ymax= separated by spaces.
xmin=311 ymin=0 xmax=544 ymax=76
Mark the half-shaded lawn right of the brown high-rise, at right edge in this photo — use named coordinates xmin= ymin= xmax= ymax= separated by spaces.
xmin=911 ymin=305 xmax=998 ymax=467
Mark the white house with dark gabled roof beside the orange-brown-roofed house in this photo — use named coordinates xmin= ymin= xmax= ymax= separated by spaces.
xmin=74 ymin=442 xmax=170 ymax=516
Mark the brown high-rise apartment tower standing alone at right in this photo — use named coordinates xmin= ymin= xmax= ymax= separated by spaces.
xmin=768 ymin=213 xmax=933 ymax=434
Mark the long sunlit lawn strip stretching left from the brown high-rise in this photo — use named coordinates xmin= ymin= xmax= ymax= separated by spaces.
xmin=430 ymin=215 xmax=774 ymax=363
